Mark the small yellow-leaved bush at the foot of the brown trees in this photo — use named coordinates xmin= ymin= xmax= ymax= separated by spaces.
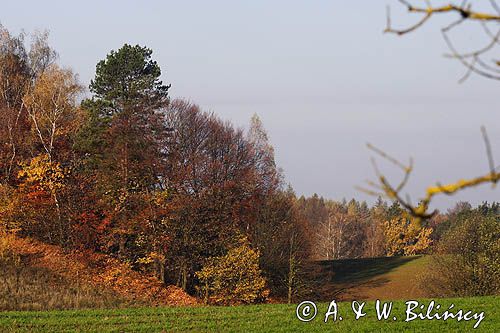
xmin=196 ymin=243 xmax=269 ymax=305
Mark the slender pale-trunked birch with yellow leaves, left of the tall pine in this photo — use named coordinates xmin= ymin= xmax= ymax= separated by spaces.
xmin=19 ymin=65 xmax=82 ymax=243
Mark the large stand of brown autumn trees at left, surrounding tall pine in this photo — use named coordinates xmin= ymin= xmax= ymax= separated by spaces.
xmin=0 ymin=27 xmax=309 ymax=299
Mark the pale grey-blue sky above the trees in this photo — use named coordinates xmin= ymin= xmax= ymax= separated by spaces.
xmin=0 ymin=0 xmax=500 ymax=209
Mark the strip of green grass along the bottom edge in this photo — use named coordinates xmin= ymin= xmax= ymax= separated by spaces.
xmin=0 ymin=296 xmax=500 ymax=333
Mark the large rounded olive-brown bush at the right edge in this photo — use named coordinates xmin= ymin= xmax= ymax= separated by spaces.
xmin=423 ymin=211 xmax=500 ymax=297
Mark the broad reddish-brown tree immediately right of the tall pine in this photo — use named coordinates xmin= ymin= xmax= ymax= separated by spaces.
xmin=162 ymin=100 xmax=256 ymax=289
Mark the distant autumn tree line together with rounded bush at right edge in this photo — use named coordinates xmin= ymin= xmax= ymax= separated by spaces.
xmin=297 ymin=194 xmax=500 ymax=297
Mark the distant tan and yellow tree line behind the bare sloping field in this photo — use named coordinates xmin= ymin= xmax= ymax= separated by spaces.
xmin=298 ymin=194 xmax=437 ymax=260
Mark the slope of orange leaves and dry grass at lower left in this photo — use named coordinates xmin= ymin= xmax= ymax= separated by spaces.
xmin=0 ymin=237 xmax=197 ymax=310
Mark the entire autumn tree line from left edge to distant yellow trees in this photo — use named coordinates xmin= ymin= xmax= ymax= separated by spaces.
xmin=0 ymin=26 xmax=498 ymax=304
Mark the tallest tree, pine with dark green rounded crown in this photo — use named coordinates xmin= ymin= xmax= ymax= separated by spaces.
xmin=76 ymin=44 xmax=170 ymax=257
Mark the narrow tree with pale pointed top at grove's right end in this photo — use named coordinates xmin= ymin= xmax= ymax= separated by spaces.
xmin=246 ymin=115 xmax=310 ymax=302
